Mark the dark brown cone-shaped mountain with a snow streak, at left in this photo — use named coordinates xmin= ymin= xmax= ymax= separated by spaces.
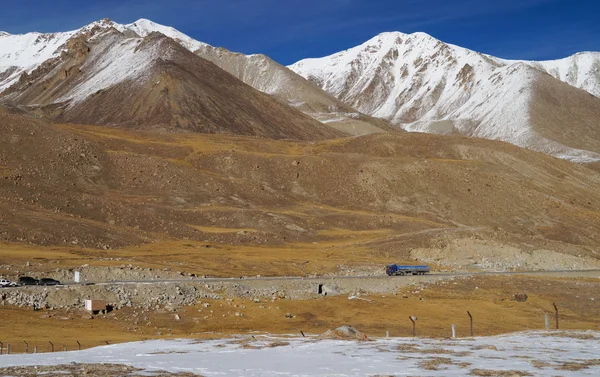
xmin=5 ymin=29 xmax=341 ymax=140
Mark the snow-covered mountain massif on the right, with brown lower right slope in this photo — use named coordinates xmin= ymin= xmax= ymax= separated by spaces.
xmin=289 ymin=32 xmax=600 ymax=162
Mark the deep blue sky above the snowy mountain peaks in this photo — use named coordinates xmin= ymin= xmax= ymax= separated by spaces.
xmin=0 ymin=0 xmax=600 ymax=64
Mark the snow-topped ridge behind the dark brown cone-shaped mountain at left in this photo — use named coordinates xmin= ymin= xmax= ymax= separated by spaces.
xmin=0 ymin=19 xmax=390 ymax=135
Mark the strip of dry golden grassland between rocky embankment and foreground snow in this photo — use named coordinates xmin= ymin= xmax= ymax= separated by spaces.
xmin=0 ymin=276 xmax=600 ymax=352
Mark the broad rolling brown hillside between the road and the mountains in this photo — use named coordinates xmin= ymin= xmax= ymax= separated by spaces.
xmin=0 ymin=108 xmax=600 ymax=268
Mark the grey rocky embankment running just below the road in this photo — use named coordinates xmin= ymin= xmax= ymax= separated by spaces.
xmin=0 ymin=275 xmax=451 ymax=310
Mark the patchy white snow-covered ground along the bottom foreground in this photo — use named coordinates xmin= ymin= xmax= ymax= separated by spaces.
xmin=0 ymin=332 xmax=600 ymax=377
